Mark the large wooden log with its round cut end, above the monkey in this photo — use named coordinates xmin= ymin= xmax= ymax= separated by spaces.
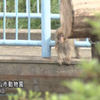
xmin=60 ymin=0 xmax=100 ymax=38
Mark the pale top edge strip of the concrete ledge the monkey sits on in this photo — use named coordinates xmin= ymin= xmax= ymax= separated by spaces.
xmin=0 ymin=55 xmax=91 ymax=65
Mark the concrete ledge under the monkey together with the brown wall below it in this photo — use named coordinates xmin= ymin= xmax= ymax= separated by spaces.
xmin=0 ymin=55 xmax=90 ymax=95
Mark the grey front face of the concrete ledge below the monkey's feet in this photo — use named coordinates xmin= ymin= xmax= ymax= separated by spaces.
xmin=0 ymin=63 xmax=79 ymax=77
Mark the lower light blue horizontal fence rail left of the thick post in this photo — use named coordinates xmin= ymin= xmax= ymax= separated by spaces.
xmin=0 ymin=40 xmax=42 ymax=46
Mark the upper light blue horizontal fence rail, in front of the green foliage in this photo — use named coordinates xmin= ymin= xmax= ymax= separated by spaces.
xmin=0 ymin=12 xmax=60 ymax=19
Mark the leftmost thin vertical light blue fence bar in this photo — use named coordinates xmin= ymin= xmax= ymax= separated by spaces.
xmin=3 ymin=0 xmax=6 ymax=40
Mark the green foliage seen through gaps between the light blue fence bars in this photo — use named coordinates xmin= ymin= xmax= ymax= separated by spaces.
xmin=0 ymin=0 xmax=60 ymax=29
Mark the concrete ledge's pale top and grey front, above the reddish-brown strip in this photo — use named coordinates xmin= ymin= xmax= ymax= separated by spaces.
xmin=0 ymin=56 xmax=91 ymax=77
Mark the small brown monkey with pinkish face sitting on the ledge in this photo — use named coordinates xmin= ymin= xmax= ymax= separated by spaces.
xmin=55 ymin=27 xmax=81 ymax=65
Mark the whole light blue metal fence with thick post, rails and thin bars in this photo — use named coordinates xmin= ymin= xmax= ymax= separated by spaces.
xmin=0 ymin=0 xmax=90 ymax=57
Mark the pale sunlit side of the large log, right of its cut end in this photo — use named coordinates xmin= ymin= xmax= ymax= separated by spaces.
xmin=72 ymin=0 xmax=100 ymax=29
